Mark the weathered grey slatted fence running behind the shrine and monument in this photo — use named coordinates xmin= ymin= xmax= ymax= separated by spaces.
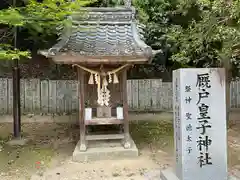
xmin=0 ymin=79 xmax=240 ymax=114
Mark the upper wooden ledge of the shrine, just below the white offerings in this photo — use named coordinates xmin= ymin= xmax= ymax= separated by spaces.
xmin=85 ymin=117 xmax=124 ymax=125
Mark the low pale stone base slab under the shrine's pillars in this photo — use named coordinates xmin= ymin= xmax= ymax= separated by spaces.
xmin=72 ymin=136 xmax=138 ymax=162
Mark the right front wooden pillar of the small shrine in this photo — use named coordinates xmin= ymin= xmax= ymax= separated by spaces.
xmin=122 ymin=67 xmax=131 ymax=149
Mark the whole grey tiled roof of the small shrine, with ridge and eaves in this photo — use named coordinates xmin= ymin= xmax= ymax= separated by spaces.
xmin=40 ymin=7 xmax=157 ymax=63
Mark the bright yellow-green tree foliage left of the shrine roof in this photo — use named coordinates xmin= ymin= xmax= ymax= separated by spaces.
xmin=0 ymin=0 xmax=93 ymax=59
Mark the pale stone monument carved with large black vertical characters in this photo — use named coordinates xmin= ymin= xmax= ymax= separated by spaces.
xmin=161 ymin=68 xmax=233 ymax=180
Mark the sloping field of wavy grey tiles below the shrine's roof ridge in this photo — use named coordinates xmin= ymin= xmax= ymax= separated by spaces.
xmin=61 ymin=24 xmax=143 ymax=56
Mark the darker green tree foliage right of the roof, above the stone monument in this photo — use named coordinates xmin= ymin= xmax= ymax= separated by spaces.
xmin=134 ymin=0 xmax=240 ymax=76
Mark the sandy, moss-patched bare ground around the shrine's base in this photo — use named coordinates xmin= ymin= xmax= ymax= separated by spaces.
xmin=0 ymin=121 xmax=240 ymax=180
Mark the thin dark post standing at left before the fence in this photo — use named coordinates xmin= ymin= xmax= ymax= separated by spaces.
xmin=12 ymin=0 xmax=21 ymax=138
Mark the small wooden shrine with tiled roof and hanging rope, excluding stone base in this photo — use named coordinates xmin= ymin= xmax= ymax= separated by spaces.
xmin=39 ymin=0 xmax=154 ymax=151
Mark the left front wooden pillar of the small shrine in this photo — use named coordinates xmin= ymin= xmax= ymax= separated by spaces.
xmin=78 ymin=68 xmax=87 ymax=151
